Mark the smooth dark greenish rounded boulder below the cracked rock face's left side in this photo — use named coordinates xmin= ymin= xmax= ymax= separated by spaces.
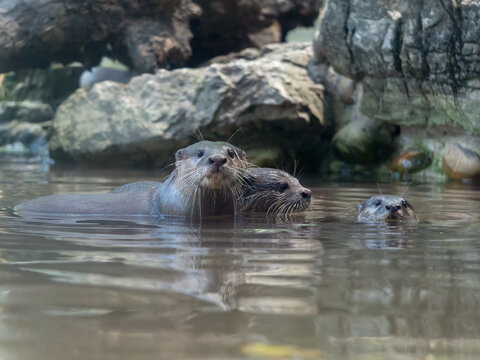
xmin=332 ymin=118 xmax=398 ymax=165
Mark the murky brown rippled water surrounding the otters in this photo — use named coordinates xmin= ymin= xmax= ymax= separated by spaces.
xmin=0 ymin=157 xmax=480 ymax=360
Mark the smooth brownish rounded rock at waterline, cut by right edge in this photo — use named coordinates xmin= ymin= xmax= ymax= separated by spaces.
xmin=443 ymin=138 xmax=480 ymax=180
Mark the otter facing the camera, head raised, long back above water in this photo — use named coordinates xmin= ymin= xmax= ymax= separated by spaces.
xmin=16 ymin=141 xmax=247 ymax=217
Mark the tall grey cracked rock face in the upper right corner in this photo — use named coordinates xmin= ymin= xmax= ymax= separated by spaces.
xmin=315 ymin=0 xmax=480 ymax=134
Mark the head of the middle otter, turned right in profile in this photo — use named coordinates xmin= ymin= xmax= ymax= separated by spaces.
xmin=240 ymin=168 xmax=312 ymax=215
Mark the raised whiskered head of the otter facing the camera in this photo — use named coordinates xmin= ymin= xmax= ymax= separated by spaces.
xmin=175 ymin=141 xmax=247 ymax=190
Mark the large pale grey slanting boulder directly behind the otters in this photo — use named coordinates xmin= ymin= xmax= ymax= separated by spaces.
xmin=51 ymin=44 xmax=330 ymax=165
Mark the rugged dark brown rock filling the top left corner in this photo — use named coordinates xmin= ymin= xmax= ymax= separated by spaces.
xmin=0 ymin=0 xmax=201 ymax=72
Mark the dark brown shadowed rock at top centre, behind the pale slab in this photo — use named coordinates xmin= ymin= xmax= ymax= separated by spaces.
xmin=190 ymin=0 xmax=324 ymax=64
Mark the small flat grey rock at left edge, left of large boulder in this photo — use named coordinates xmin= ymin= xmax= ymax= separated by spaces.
xmin=0 ymin=101 xmax=54 ymax=123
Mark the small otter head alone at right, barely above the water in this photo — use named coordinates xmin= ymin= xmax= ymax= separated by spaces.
xmin=357 ymin=195 xmax=418 ymax=222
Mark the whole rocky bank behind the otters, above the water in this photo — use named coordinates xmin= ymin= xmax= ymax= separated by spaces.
xmin=0 ymin=0 xmax=480 ymax=180
